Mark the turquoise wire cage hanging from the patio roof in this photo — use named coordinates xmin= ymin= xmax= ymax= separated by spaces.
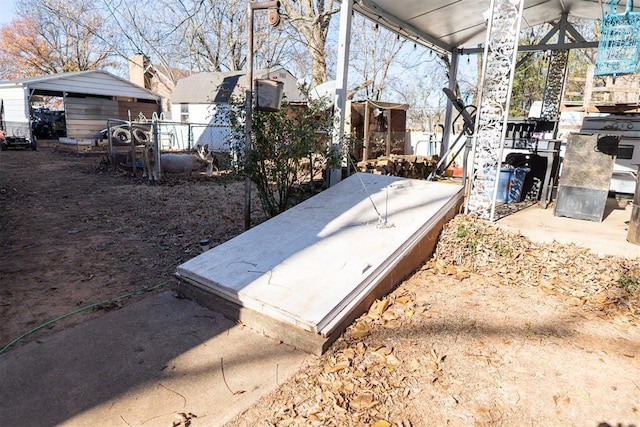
xmin=595 ymin=0 xmax=640 ymax=78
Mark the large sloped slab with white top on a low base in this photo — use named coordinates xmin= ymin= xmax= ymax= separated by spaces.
xmin=176 ymin=173 xmax=463 ymax=354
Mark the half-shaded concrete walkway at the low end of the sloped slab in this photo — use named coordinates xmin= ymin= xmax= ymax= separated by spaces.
xmin=0 ymin=291 xmax=312 ymax=427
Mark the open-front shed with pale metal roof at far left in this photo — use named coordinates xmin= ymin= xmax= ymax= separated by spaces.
xmin=0 ymin=70 xmax=161 ymax=138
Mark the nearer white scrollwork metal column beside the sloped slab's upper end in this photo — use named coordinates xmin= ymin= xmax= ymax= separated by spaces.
xmin=465 ymin=0 xmax=524 ymax=221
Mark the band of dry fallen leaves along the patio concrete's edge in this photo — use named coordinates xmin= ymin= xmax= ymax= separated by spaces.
xmin=430 ymin=215 xmax=640 ymax=324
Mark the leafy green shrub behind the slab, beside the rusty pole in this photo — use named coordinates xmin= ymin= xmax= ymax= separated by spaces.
xmin=230 ymin=90 xmax=332 ymax=217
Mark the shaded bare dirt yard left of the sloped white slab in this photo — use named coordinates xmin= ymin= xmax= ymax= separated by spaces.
xmin=0 ymin=148 xmax=264 ymax=354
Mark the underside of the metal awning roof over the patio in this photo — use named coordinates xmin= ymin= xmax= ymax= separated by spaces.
xmin=353 ymin=0 xmax=640 ymax=53
